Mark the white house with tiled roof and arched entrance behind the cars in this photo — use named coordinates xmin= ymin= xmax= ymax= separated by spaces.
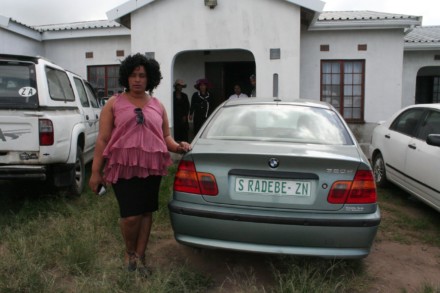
xmin=0 ymin=0 xmax=440 ymax=151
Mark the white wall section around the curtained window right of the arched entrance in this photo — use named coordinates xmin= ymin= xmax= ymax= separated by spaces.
xmin=300 ymin=30 xmax=404 ymax=123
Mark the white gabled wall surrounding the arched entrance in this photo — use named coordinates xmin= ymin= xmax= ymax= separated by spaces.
xmin=131 ymin=0 xmax=300 ymax=116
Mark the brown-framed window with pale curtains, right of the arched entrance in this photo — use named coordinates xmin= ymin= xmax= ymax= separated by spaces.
xmin=321 ymin=60 xmax=365 ymax=122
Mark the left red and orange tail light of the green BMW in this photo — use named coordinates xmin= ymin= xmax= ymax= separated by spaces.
xmin=174 ymin=160 xmax=218 ymax=196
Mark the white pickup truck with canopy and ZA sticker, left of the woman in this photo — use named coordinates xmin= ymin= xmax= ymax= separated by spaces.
xmin=0 ymin=54 xmax=101 ymax=195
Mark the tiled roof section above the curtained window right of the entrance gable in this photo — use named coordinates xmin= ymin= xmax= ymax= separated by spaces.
xmin=310 ymin=10 xmax=422 ymax=30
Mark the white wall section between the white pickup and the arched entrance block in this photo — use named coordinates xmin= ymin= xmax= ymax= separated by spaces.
xmin=44 ymin=36 xmax=131 ymax=78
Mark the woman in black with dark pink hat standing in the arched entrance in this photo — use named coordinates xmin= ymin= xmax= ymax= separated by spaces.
xmin=189 ymin=78 xmax=214 ymax=135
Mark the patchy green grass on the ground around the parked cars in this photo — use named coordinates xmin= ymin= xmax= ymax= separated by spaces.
xmin=0 ymin=166 xmax=440 ymax=293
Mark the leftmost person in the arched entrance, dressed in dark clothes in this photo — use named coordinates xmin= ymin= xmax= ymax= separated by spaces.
xmin=173 ymin=79 xmax=189 ymax=141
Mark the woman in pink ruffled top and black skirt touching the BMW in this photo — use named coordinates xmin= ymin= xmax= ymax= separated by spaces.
xmin=89 ymin=53 xmax=190 ymax=271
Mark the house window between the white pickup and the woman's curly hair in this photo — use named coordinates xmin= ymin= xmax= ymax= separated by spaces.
xmin=87 ymin=65 xmax=124 ymax=99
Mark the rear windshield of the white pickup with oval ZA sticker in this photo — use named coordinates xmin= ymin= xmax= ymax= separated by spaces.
xmin=0 ymin=62 xmax=38 ymax=109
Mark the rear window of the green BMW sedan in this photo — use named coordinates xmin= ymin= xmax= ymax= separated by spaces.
xmin=202 ymin=104 xmax=353 ymax=145
